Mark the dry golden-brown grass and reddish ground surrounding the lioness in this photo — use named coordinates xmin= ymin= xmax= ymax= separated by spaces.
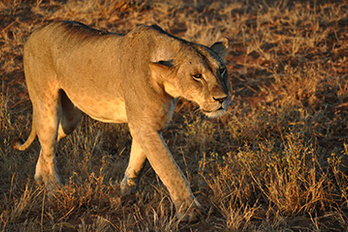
xmin=0 ymin=0 xmax=348 ymax=231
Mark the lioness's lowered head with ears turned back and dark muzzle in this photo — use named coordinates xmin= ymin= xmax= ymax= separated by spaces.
xmin=150 ymin=38 xmax=230 ymax=117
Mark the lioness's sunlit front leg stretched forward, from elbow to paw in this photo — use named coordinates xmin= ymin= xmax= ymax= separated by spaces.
xmin=132 ymin=129 xmax=201 ymax=221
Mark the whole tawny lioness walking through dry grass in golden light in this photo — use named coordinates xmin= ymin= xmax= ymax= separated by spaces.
xmin=14 ymin=22 xmax=230 ymax=220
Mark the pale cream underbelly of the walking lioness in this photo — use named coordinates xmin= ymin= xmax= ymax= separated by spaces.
xmin=67 ymin=93 xmax=128 ymax=123
